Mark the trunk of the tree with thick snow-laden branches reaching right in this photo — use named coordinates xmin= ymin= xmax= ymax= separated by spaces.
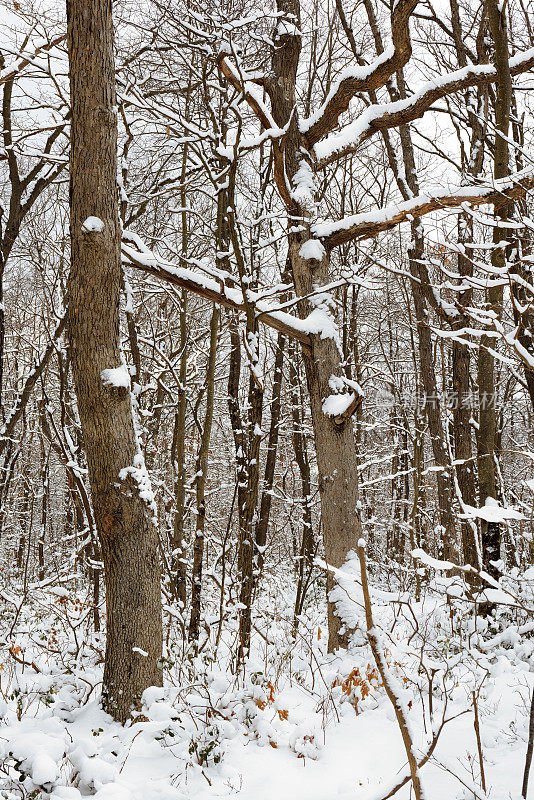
xmin=267 ymin=0 xmax=361 ymax=651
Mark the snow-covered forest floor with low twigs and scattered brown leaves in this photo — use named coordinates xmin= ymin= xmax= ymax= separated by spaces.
xmin=0 ymin=569 xmax=534 ymax=800
